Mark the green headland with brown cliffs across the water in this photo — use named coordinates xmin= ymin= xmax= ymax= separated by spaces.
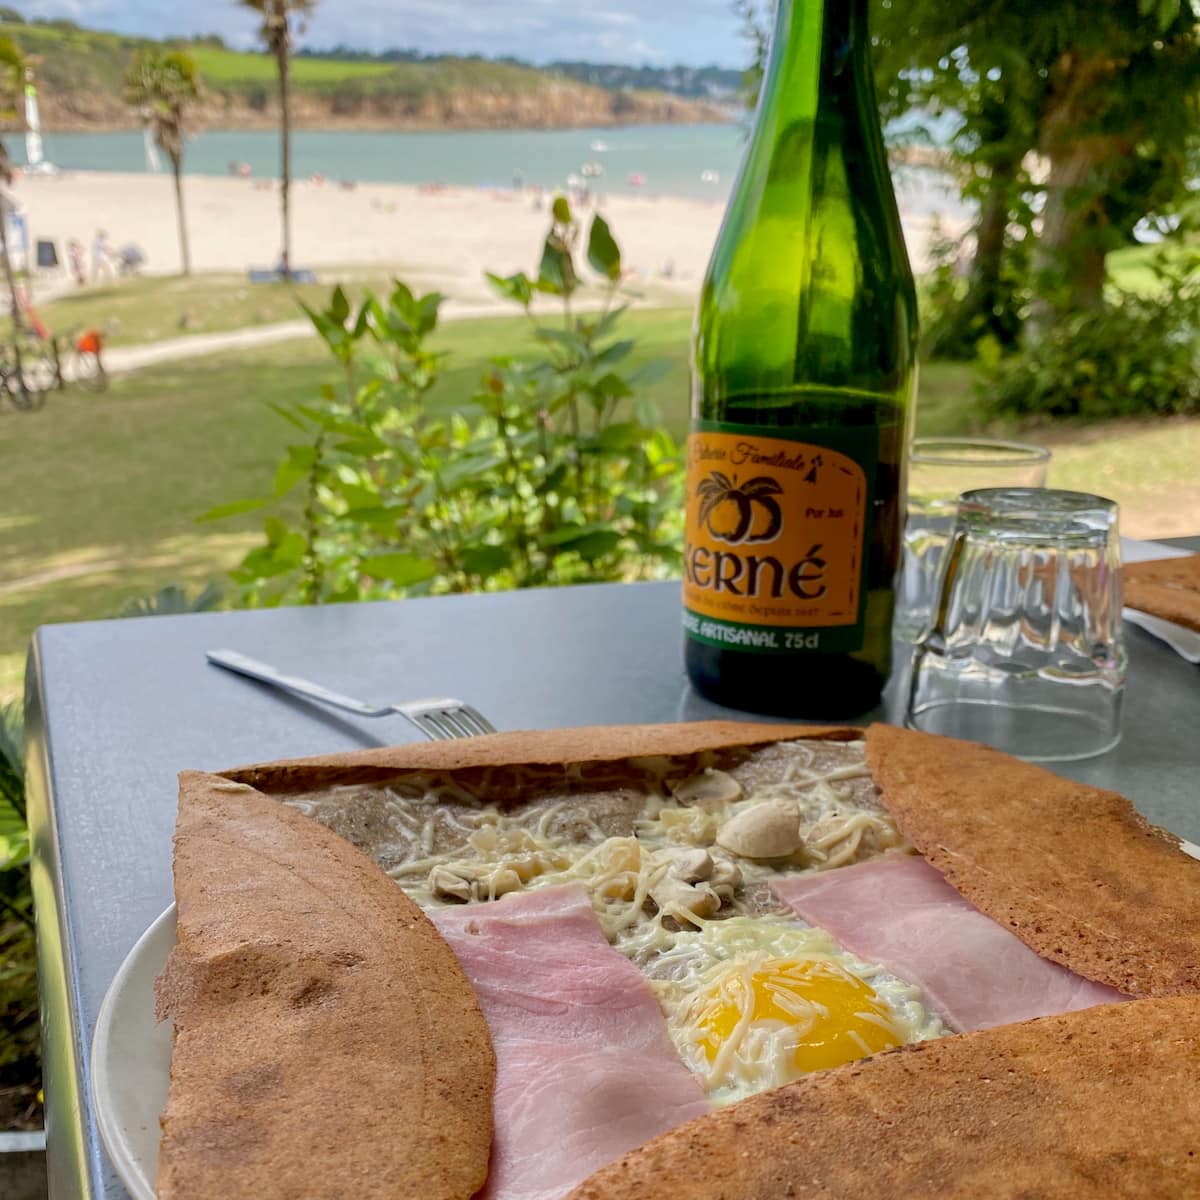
xmin=0 ymin=20 xmax=721 ymax=132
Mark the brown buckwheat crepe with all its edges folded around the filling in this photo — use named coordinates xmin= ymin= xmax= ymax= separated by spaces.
xmin=160 ymin=721 xmax=1200 ymax=1200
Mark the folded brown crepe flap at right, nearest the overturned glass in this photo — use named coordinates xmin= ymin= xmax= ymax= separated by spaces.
xmin=866 ymin=725 xmax=1200 ymax=997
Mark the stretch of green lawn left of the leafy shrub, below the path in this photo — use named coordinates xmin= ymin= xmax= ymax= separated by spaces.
xmin=0 ymin=347 xmax=320 ymax=696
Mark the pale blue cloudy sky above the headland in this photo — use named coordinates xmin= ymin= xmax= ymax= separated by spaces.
xmin=16 ymin=0 xmax=748 ymax=67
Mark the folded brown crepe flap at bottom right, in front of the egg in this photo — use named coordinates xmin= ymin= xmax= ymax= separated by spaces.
xmin=569 ymin=996 xmax=1200 ymax=1200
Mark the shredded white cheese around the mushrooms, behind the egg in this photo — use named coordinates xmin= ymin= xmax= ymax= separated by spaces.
xmin=290 ymin=740 xmax=902 ymax=962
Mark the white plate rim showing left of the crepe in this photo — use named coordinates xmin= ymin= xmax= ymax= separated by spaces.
xmin=91 ymin=905 xmax=175 ymax=1200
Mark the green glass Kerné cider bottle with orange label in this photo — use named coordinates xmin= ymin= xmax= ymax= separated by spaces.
xmin=684 ymin=0 xmax=917 ymax=718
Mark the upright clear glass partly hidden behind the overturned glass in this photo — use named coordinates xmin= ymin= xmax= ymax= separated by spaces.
xmin=893 ymin=438 xmax=1050 ymax=642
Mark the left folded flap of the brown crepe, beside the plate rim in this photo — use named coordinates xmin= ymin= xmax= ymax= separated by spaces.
xmin=156 ymin=772 xmax=496 ymax=1200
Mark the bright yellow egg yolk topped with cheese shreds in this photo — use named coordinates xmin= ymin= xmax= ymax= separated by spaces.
xmin=697 ymin=959 xmax=904 ymax=1074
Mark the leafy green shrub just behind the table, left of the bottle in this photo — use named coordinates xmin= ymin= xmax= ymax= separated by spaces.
xmin=208 ymin=197 xmax=682 ymax=605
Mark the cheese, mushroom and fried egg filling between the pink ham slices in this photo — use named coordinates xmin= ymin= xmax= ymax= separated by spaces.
xmin=289 ymin=740 xmax=944 ymax=1103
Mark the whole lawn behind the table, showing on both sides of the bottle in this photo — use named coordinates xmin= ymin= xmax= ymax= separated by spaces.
xmin=0 ymin=310 xmax=1200 ymax=698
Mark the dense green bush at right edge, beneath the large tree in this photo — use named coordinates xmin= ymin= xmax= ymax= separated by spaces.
xmin=983 ymin=241 xmax=1200 ymax=419
